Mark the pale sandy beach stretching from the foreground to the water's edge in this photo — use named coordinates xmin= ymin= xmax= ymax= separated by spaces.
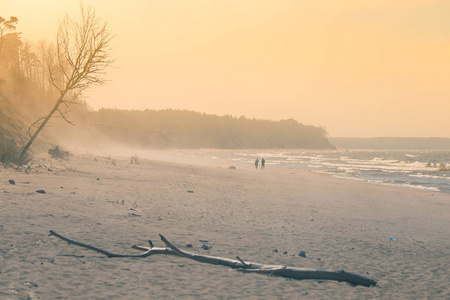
xmin=0 ymin=155 xmax=450 ymax=299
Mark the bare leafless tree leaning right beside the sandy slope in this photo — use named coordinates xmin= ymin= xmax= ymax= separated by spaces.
xmin=19 ymin=5 xmax=112 ymax=164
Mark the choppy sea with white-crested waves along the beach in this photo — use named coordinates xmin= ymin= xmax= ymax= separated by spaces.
xmin=191 ymin=150 xmax=450 ymax=193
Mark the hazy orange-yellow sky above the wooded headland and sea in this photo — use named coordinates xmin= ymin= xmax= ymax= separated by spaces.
xmin=0 ymin=0 xmax=450 ymax=137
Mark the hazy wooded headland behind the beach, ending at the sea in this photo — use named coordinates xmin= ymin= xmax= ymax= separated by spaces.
xmin=73 ymin=109 xmax=333 ymax=149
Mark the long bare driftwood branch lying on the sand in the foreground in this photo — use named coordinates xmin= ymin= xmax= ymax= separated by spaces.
xmin=50 ymin=230 xmax=377 ymax=287
